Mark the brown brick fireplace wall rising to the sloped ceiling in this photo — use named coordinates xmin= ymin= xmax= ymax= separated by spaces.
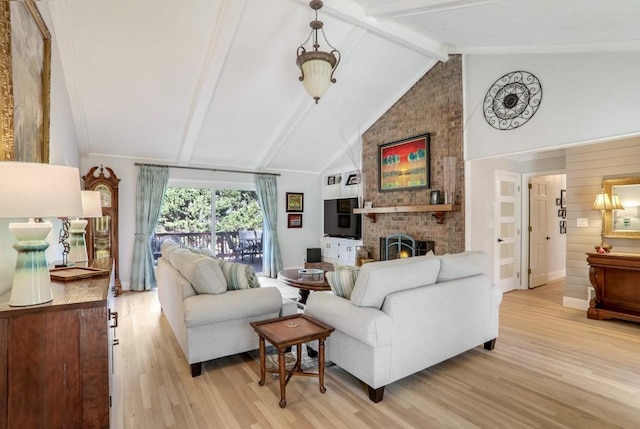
xmin=362 ymin=55 xmax=465 ymax=259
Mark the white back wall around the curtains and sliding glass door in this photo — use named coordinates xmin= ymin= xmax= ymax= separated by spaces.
xmin=81 ymin=156 xmax=322 ymax=290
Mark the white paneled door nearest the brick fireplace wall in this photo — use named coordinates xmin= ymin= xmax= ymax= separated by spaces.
xmin=494 ymin=171 xmax=520 ymax=292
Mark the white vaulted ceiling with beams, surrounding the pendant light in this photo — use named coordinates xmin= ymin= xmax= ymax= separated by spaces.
xmin=48 ymin=0 xmax=640 ymax=172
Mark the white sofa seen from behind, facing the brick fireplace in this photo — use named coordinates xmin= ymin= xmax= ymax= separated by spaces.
xmin=305 ymin=252 xmax=502 ymax=402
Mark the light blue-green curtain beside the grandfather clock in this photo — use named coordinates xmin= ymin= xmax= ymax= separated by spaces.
xmin=131 ymin=165 xmax=169 ymax=291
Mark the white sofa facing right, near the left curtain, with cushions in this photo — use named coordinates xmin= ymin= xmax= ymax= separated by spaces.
xmin=156 ymin=242 xmax=296 ymax=377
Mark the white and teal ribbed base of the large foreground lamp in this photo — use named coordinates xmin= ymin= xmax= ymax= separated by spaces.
xmin=9 ymin=221 xmax=53 ymax=307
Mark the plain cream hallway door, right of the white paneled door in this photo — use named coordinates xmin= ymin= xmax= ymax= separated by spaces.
xmin=529 ymin=177 xmax=549 ymax=288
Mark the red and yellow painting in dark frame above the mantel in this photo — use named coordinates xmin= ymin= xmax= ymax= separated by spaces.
xmin=378 ymin=133 xmax=431 ymax=191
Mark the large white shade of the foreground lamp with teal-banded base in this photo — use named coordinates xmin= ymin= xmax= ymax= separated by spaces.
xmin=0 ymin=161 xmax=82 ymax=218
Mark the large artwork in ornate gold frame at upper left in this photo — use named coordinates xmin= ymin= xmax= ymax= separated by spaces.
xmin=0 ymin=0 xmax=51 ymax=163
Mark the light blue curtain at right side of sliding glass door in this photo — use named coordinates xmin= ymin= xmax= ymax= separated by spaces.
xmin=256 ymin=174 xmax=282 ymax=278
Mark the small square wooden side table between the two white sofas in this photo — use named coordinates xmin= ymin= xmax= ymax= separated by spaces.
xmin=250 ymin=314 xmax=334 ymax=408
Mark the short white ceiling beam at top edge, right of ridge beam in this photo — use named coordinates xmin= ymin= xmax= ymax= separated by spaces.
xmin=364 ymin=0 xmax=503 ymax=19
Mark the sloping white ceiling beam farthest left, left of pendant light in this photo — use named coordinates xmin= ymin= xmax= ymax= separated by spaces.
xmin=178 ymin=0 xmax=247 ymax=165
